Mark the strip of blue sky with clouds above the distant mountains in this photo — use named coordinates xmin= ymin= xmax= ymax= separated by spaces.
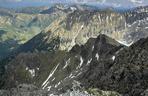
xmin=0 ymin=0 xmax=148 ymax=8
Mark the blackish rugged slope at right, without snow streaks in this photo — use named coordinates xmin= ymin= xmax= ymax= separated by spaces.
xmin=89 ymin=36 xmax=148 ymax=96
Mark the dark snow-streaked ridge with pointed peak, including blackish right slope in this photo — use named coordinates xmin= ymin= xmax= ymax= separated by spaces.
xmin=4 ymin=35 xmax=148 ymax=96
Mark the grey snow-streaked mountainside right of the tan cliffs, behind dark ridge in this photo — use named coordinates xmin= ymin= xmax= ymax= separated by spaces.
xmin=125 ymin=6 xmax=148 ymax=42
